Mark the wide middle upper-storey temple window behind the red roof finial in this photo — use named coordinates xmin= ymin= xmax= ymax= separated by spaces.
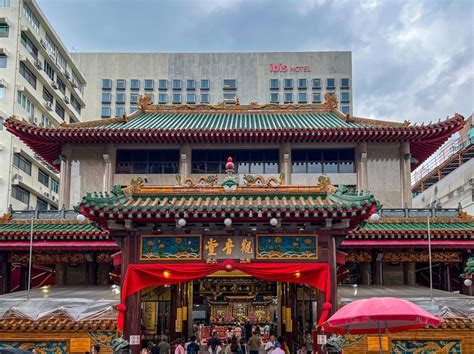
xmin=192 ymin=149 xmax=279 ymax=174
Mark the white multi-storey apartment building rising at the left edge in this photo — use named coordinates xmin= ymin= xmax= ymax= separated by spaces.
xmin=0 ymin=0 xmax=86 ymax=215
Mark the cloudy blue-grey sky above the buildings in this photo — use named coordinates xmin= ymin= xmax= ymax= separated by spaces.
xmin=37 ymin=0 xmax=474 ymax=122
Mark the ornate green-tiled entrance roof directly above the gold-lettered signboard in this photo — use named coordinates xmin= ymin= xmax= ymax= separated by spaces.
xmin=80 ymin=177 xmax=379 ymax=228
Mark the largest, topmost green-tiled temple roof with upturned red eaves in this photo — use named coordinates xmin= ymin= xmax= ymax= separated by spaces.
xmin=4 ymin=95 xmax=464 ymax=169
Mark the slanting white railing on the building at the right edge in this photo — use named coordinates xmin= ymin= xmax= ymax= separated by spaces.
xmin=411 ymin=128 xmax=474 ymax=187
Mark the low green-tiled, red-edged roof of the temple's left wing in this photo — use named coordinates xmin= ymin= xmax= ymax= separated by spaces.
xmin=0 ymin=211 xmax=119 ymax=250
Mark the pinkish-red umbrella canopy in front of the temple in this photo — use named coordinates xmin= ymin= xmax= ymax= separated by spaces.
xmin=324 ymin=297 xmax=442 ymax=334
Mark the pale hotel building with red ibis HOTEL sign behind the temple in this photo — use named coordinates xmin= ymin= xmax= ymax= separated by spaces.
xmin=72 ymin=52 xmax=352 ymax=120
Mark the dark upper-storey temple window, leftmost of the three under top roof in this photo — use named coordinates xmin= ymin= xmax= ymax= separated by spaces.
xmin=116 ymin=149 xmax=179 ymax=174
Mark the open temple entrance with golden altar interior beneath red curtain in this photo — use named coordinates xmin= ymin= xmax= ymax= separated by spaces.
xmin=141 ymin=271 xmax=321 ymax=351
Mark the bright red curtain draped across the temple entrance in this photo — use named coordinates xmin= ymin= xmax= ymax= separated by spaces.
xmin=117 ymin=260 xmax=332 ymax=331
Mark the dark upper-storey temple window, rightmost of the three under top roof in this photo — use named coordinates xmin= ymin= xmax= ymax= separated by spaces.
xmin=291 ymin=149 xmax=355 ymax=173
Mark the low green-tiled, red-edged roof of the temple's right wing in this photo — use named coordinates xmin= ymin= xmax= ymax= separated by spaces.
xmin=342 ymin=209 xmax=474 ymax=248
